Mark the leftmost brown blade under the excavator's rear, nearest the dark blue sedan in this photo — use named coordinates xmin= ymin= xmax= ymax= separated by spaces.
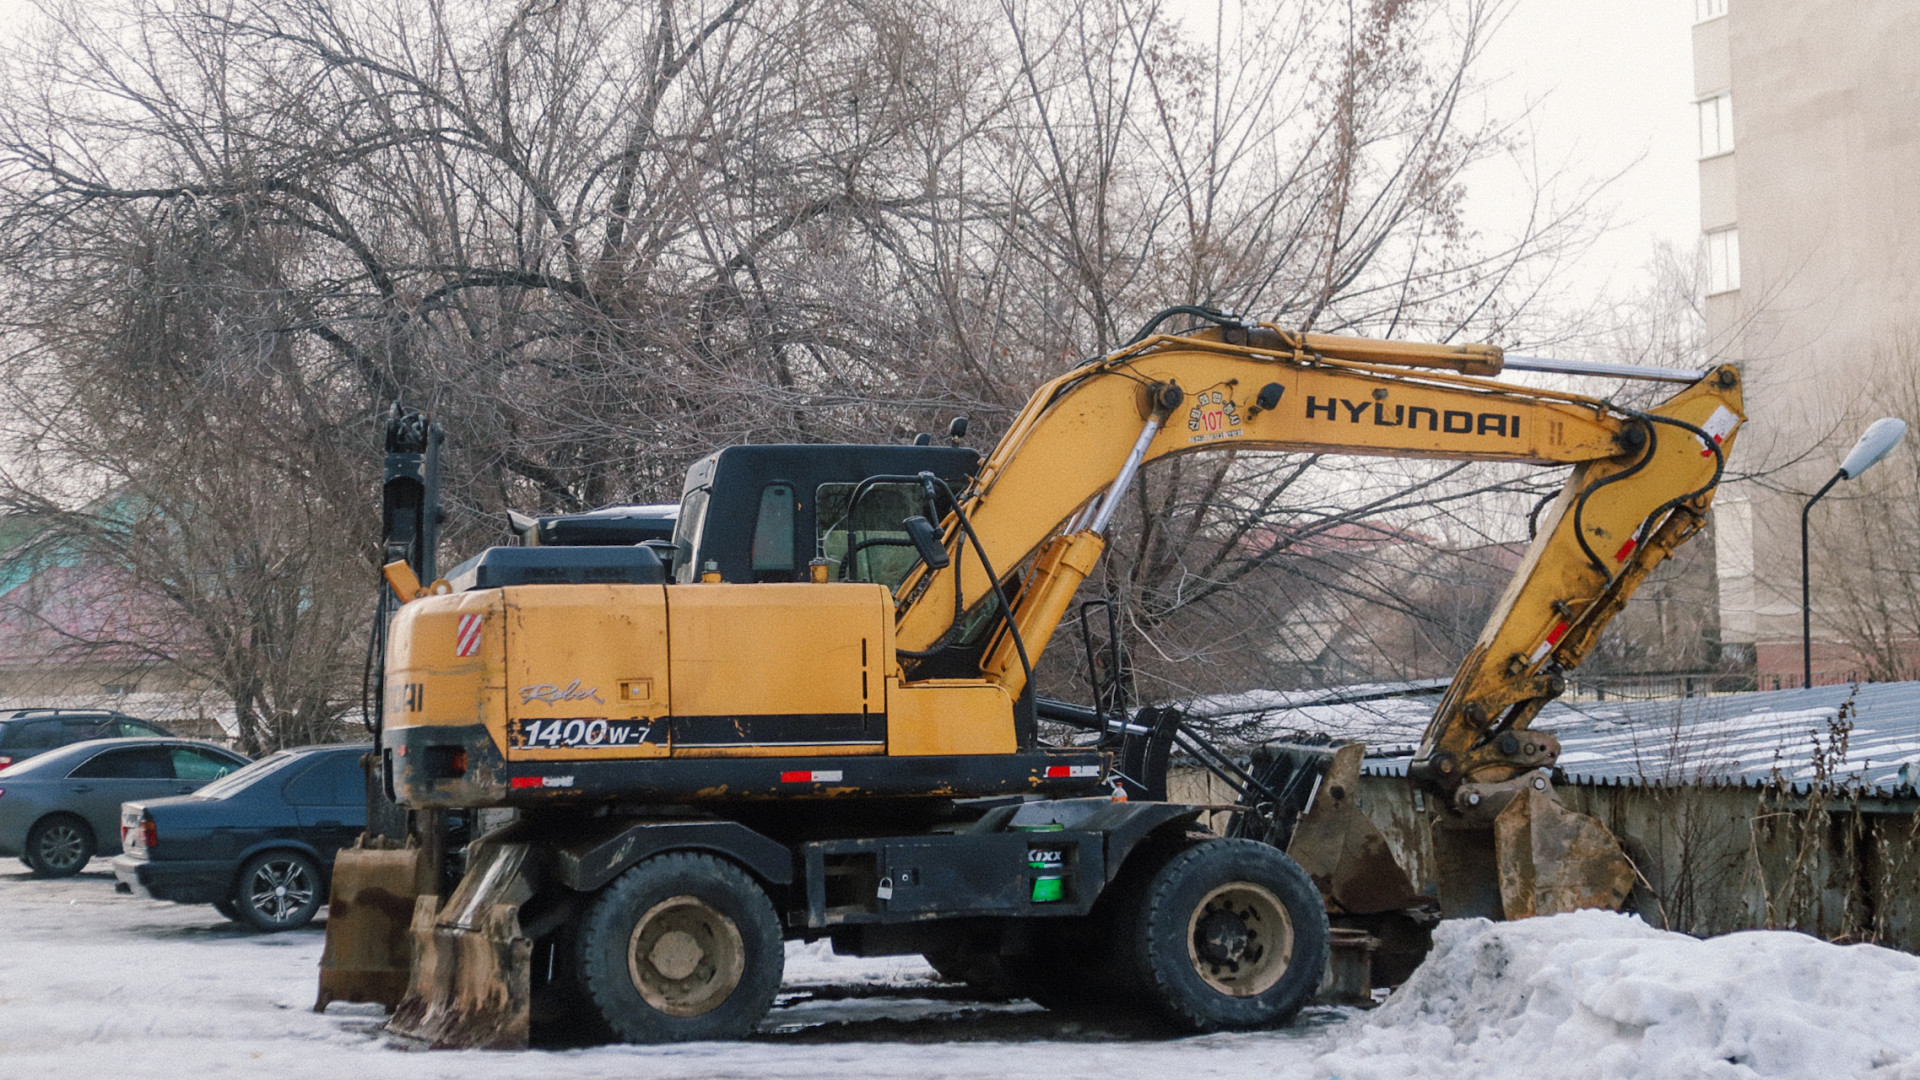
xmin=313 ymin=836 xmax=434 ymax=1013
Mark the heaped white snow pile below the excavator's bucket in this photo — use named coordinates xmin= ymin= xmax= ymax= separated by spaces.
xmin=1315 ymin=911 xmax=1920 ymax=1080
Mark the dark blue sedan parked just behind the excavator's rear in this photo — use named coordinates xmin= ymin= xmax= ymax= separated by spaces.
xmin=113 ymin=744 xmax=372 ymax=930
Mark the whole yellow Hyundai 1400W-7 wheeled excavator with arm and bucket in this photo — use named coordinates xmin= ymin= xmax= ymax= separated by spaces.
xmin=321 ymin=307 xmax=1741 ymax=1047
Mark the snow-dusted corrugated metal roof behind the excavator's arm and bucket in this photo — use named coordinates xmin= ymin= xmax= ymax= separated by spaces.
xmin=1175 ymin=682 xmax=1920 ymax=796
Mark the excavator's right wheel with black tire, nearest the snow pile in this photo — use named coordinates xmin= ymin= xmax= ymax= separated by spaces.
xmin=1117 ymin=840 xmax=1329 ymax=1032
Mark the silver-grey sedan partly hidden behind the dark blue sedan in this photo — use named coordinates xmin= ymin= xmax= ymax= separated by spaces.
xmin=0 ymin=738 xmax=248 ymax=878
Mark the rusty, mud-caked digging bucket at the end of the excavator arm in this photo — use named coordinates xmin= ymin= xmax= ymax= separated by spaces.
xmin=1494 ymin=786 xmax=1634 ymax=919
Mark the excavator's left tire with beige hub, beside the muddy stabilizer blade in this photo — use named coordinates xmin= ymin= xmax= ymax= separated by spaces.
xmin=578 ymin=851 xmax=787 ymax=1043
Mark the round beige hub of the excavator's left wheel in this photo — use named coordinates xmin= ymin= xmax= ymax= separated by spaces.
xmin=626 ymin=896 xmax=747 ymax=1017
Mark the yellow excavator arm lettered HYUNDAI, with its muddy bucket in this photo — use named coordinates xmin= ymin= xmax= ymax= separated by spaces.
xmin=897 ymin=315 xmax=1743 ymax=917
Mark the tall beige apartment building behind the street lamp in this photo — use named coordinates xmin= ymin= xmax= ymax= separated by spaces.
xmin=1678 ymin=0 xmax=1920 ymax=690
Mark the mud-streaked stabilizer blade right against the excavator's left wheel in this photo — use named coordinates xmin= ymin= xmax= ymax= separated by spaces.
xmin=386 ymin=844 xmax=534 ymax=1049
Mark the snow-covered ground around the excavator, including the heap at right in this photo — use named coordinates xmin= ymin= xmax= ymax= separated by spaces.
xmin=0 ymin=861 xmax=1920 ymax=1080
